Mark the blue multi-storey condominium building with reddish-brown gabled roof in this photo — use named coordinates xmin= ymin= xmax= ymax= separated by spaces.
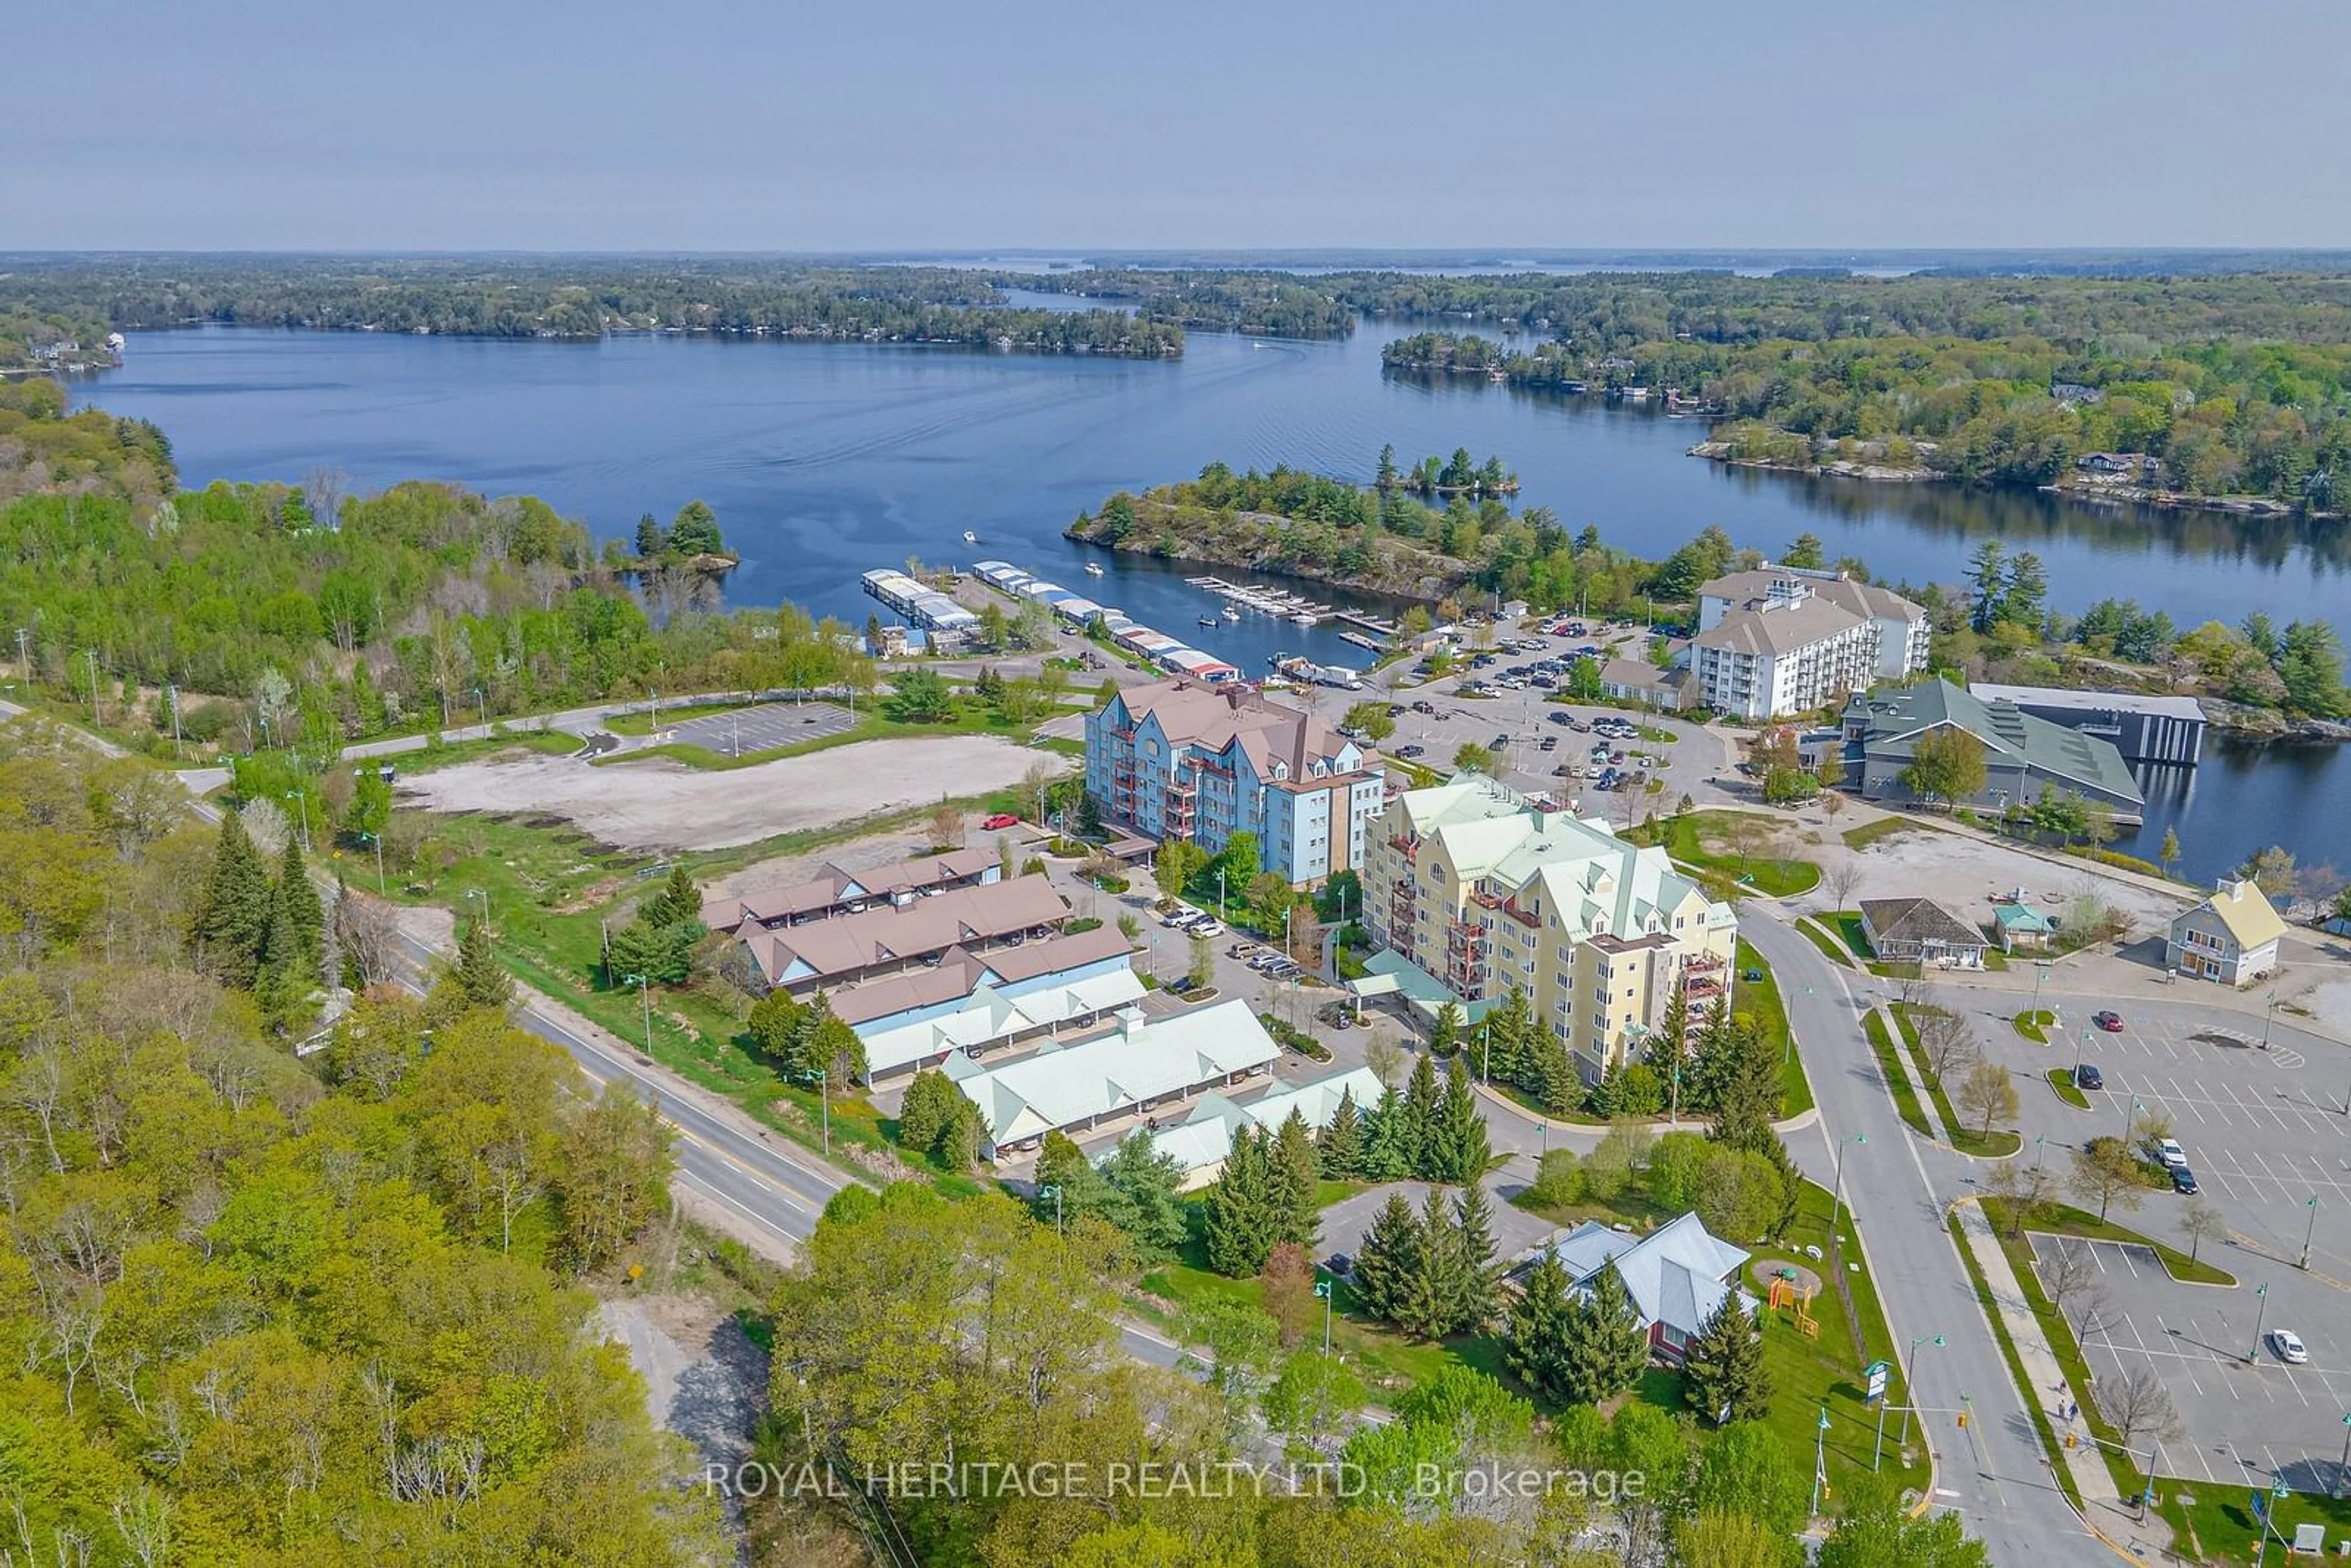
xmin=1086 ymin=680 xmax=1382 ymax=884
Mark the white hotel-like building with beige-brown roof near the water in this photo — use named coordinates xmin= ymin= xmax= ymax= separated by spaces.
xmin=1690 ymin=566 xmax=1930 ymax=719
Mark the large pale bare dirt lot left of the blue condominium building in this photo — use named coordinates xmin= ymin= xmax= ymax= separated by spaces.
xmin=402 ymin=736 xmax=1067 ymax=849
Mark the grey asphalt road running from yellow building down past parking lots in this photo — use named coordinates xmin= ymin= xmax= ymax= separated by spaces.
xmin=1740 ymin=917 xmax=2113 ymax=1566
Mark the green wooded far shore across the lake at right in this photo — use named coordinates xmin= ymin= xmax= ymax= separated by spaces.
xmin=1333 ymin=275 xmax=2351 ymax=510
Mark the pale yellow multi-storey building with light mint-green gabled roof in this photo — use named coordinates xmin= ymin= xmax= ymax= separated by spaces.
xmin=1363 ymin=776 xmax=1738 ymax=1081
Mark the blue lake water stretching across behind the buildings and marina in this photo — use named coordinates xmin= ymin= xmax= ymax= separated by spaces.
xmin=75 ymin=322 xmax=2351 ymax=874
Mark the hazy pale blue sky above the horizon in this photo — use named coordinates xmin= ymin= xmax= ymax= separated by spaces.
xmin=0 ymin=0 xmax=2351 ymax=249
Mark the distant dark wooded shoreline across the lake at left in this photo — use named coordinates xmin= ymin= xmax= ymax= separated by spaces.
xmin=0 ymin=257 xmax=1183 ymax=358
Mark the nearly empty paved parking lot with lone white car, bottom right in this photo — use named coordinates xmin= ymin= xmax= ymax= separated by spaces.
xmin=2034 ymin=1237 xmax=2351 ymax=1490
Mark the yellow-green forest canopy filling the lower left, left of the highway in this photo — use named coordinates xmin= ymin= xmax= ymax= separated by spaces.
xmin=0 ymin=719 xmax=727 ymax=1566
